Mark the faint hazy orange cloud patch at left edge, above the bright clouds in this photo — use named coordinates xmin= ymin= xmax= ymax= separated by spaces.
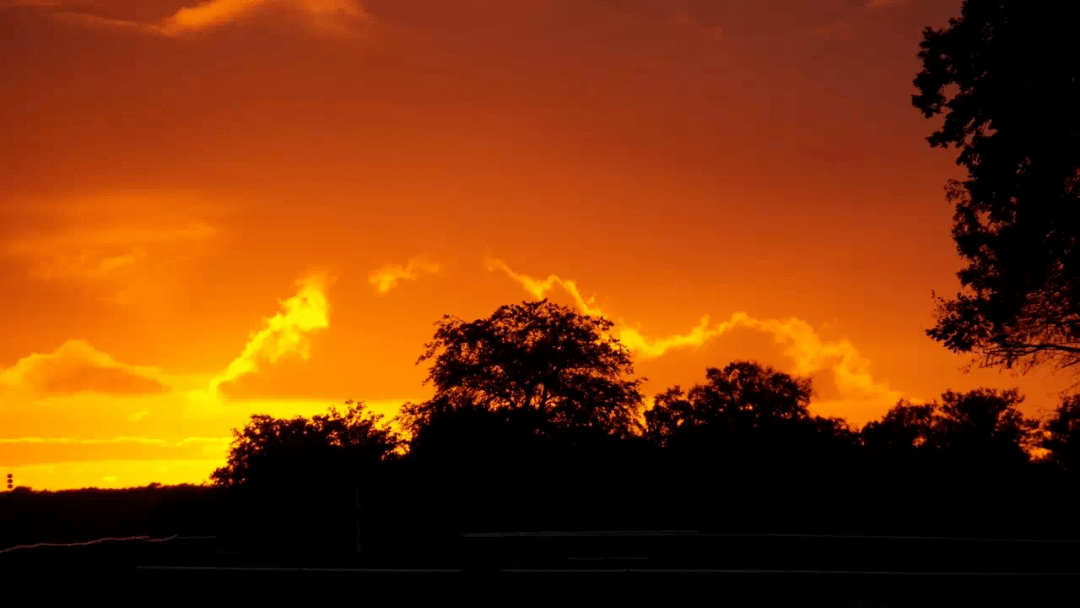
xmin=0 ymin=192 xmax=228 ymax=308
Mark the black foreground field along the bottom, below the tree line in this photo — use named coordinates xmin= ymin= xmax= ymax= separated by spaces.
xmin=0 ymin=532 xmax=1080 ymax=607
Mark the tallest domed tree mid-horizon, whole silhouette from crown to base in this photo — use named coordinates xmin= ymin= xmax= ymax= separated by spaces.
xmin=401 ymin=300 xmax=643 ymax=535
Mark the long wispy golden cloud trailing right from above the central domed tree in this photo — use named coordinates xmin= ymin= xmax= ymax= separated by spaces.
xmin=487 ymin=260 xmax=902 ymax=421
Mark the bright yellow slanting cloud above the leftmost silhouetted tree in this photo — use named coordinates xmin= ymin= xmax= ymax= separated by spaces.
xmin=210 ymin=275 xmax=333 ymax=394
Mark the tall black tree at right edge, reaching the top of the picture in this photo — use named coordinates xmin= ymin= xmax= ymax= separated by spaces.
xmin=913 ymin=0 xmax=1080 ymax=369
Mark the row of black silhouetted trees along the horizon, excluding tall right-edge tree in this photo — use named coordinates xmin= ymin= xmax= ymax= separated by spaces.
xmin=213 ymin=300 xmax=1080 ymax=546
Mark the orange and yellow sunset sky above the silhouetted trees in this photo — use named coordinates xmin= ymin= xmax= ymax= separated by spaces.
xmin=0 ymin=0 xmax=1070 ymax=489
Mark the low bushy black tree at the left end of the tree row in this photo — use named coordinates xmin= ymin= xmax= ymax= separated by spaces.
xmin=212 ymin=402 xmax=402 ymax=553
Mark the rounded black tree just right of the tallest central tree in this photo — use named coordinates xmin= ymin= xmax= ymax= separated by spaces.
xmin=645 ymin=361 xmax=858 ymax=531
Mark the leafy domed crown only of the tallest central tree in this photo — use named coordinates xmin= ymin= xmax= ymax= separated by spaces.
xmin=403 ymin=300 xmax=642 ymax=436
